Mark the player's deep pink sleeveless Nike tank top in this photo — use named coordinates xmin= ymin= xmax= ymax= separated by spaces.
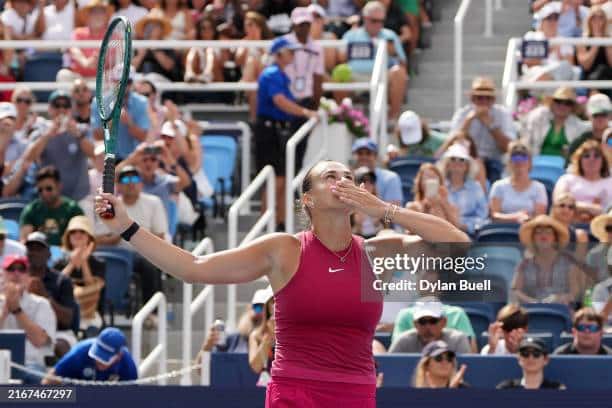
xmin=272 ymin=231 xmax=382 ymax=384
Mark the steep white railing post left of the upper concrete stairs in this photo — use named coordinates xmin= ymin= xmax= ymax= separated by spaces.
xmin=370 ymin=41 xmax=388 ymax=156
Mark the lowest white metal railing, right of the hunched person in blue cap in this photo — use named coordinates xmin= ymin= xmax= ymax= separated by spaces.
xmin=131 ymin=292 xmax=168 ymax=385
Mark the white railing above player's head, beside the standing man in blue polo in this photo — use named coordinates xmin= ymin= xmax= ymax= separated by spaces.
xmin=285 ymin=110 xmax=330 ymax=234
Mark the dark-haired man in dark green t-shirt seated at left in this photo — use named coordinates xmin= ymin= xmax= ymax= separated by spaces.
xmin=19 ymin=166 xmax=83 ymax=245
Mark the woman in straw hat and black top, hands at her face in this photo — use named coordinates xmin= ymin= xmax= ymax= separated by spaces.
xmin=53 ymin=215 xmax=106 ymax=333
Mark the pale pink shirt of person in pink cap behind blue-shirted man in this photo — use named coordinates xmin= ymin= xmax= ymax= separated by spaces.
xmin=285 ymin=33 xmax=325 ymax=100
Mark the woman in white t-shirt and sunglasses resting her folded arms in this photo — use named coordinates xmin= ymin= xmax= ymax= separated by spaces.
xmin=489 ymin=141 xmax=548 ymax=224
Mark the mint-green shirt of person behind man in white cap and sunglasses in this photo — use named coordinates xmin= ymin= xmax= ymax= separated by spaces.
xmin=391 ymin=298 xmax=478 ymax=351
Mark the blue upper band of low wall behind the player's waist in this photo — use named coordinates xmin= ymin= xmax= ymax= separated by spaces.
xmin=210 ymin=353 xmax=612 ymax=390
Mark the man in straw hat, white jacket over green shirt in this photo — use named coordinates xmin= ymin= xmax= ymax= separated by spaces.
xmin=521 ymin=87 xmax=588 ymax=156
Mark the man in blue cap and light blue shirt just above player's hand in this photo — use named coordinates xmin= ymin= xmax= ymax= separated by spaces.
xmin=351 ymin=137 xmax=404 ymax=205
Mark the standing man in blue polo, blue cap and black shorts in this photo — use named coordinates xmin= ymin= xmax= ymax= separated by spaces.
xmin=254 ymin=37 xmax=317 ymax=230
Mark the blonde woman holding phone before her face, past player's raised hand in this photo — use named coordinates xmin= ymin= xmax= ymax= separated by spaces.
xmin=406 ymin=163 xmax=461 ymax=231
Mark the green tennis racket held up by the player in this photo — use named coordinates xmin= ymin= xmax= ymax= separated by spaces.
xmin=96 ymin=17 xmax=132 ymax=218
